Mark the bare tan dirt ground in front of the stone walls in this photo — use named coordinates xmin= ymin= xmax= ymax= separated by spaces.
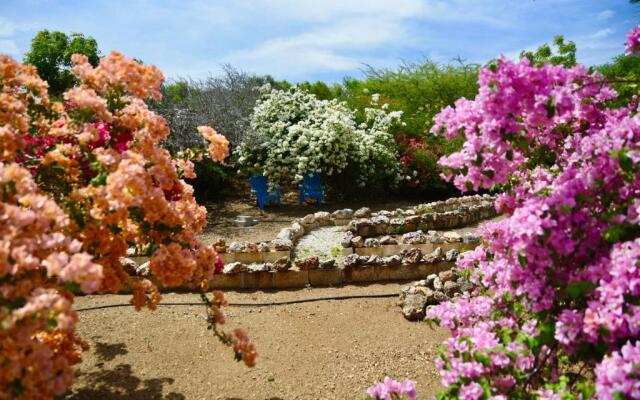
xmin=67 ymin=284 xmax=447 ymax=400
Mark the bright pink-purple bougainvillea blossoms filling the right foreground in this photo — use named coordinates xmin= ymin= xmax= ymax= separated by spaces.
xmin=427 ymin=28 xmax=640 ymax=399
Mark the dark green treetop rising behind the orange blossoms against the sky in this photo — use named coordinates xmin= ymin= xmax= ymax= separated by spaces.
xmin=24 ymin=29 xmax=100 ymax=97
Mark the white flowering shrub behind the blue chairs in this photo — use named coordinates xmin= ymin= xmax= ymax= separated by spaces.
xmin=236 ymin=87 xmax=402 ymax=186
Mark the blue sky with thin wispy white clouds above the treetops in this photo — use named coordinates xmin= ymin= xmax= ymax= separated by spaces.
xmin=0 ymin=0 xmax=640 ymax=81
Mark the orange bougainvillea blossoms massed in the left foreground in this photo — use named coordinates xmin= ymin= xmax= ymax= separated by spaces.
xmin=0 ymin=52 xmax=255 ymax=398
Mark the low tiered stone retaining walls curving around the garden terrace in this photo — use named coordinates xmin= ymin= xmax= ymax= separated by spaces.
xmin=122 ymin=195 xmax=496 ymax=289
